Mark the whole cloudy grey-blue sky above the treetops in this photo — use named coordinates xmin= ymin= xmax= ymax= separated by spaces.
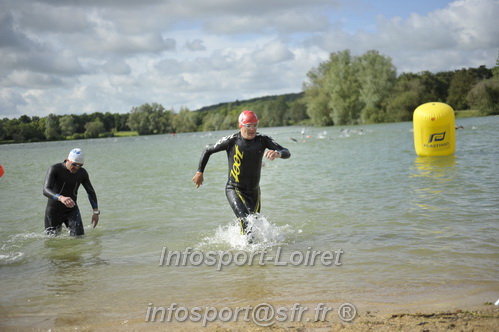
xmin=0 ymin=0 xmax=499 ymax=118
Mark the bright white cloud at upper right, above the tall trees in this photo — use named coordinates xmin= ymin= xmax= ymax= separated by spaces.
xmin=307 ymin=0 xmax=499 ymax=72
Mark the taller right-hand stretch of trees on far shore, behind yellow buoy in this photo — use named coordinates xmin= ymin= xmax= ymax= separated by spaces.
xmin=304 ymin=50 xmax=499 ymax=126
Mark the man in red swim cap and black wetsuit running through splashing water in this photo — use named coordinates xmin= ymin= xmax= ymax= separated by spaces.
xmin=192 ymin=110 xmax=291 ymax=240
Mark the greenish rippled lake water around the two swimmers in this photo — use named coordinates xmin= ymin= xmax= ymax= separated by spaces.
xmin=0 ymin=116 xmax=499 ymax=329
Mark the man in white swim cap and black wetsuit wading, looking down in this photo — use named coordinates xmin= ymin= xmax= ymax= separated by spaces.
xmin=43 ymin=148 xmax=100 ymax=236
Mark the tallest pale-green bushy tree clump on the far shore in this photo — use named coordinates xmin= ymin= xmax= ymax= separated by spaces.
xmin=304 ymin=50 xmax=396 ymax=126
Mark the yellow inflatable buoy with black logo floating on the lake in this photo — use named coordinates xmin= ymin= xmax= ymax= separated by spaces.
xmin=412 ymin=102 xmax=456 ymax=157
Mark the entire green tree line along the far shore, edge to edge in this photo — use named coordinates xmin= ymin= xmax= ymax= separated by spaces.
xmin=0 ymin=50 xmax=499 ymax=142
